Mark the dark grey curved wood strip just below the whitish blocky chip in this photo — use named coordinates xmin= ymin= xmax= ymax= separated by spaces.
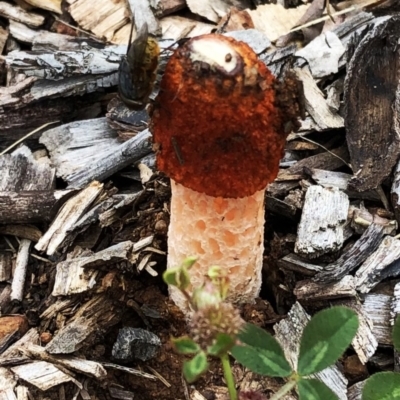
xmin=313 ymin=224 xmax=384 ymax=283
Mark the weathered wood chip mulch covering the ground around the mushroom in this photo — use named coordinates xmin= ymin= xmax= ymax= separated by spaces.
xmin=0 ymin=0 xmax=400 ymax=400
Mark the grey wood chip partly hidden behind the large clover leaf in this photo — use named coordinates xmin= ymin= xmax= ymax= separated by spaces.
xmin=274 ymin=302 xmax=347 ymax=400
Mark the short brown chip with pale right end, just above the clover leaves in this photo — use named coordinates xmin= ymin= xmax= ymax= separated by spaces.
xmin=293 ymin=275 xmax=357 ymax=302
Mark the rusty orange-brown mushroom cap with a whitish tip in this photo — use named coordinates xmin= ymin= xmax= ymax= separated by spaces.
xmin=151 ymin=34 xmax=286 ymax=198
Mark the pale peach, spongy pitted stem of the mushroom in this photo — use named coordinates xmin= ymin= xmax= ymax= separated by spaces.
xmin=168 ymin=180 xmax=265 ymax=311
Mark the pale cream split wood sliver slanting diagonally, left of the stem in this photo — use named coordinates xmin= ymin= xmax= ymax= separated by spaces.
xmin=35 ymin=182 xmax=103 ymax=255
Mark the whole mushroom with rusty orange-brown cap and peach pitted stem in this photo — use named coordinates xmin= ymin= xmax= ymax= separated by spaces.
xmin=151 ymin=34 xmax=298 ymax=310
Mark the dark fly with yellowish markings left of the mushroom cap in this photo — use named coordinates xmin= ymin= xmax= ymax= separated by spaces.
xmin=118 ymin=22 xmax=160 ymax=110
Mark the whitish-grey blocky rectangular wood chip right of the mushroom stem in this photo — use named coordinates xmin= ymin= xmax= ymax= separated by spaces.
xmin=295 ymin=186 xmax=349 ymax=257
